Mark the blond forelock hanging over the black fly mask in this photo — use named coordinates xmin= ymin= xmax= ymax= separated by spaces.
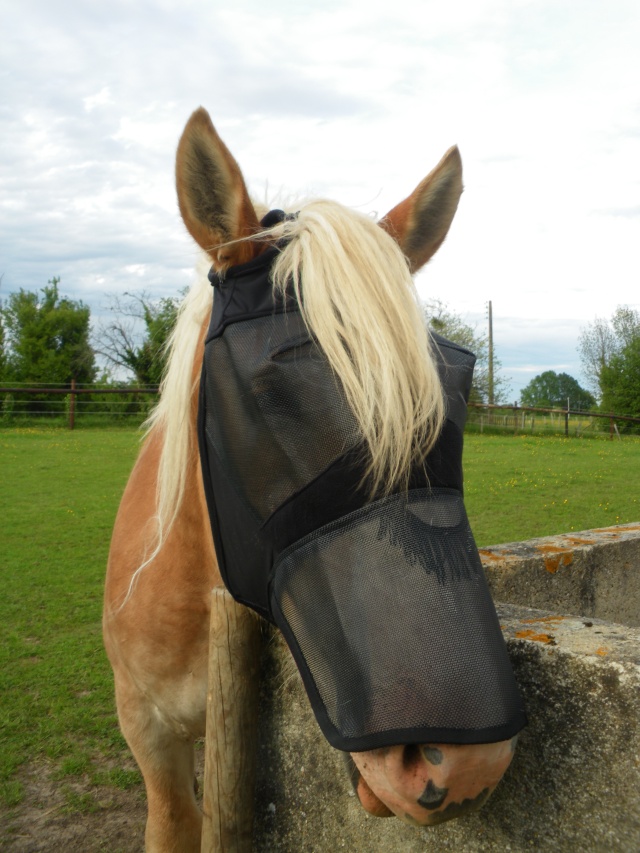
xmin=273 ymin=200 xmax=444 ymax=492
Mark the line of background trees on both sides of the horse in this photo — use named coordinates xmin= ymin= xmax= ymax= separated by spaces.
xmin=0 ymin=277 xmax=640 ymax=426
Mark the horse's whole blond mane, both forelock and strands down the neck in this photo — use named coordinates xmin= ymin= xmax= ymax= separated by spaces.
xmin=142 ymin=200 xmax=444 ymax=574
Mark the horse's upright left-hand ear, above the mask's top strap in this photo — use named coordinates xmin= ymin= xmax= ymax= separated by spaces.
xmin=176 ymin=107 xmax=262 ymax=269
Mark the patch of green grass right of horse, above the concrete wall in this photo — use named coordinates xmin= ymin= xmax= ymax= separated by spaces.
xmin=464 ymin=434 xmax=640 ymax=546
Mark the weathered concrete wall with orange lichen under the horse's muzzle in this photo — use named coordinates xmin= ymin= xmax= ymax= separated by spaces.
xmin=254 ymin=524 xmax=640 ymax=853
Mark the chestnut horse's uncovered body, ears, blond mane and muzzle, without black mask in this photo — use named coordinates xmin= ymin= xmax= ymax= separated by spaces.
xmin=103 ymin=108 xmax=515 ymax=853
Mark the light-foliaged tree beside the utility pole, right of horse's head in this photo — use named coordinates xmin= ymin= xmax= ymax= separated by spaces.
xmin=424 ymin=299 xmax=507 ymax=403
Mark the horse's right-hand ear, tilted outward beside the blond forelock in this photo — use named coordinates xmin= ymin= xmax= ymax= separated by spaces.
xmin=380 ymin=145 xmax=462 ymax=272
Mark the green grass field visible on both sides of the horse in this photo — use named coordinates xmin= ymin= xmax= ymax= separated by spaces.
xmin=0 ymin=429 xmax=640 ymax=811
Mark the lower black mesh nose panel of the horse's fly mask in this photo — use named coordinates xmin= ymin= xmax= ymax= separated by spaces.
xmin=272 ymin=489 xmax=522 ymax=751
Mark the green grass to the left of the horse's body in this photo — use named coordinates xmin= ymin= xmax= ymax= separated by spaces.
xmin=0 ymin=429 xmax=139 ymax=805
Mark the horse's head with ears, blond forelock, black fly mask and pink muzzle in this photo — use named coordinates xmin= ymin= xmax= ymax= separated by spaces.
xmin=176 ymin=109 xmax=524 ymax=825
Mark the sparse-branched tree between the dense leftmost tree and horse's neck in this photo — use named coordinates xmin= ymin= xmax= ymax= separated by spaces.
xmin=96 ymin=293 xmax=184 ymax=385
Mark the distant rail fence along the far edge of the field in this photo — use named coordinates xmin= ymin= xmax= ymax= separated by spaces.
xmin=0 ymin=382 xmax=640 ymax=439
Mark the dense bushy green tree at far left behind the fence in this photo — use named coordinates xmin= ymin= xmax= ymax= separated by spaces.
xmin=0 ymin=277 xmax=96 ymax=386
